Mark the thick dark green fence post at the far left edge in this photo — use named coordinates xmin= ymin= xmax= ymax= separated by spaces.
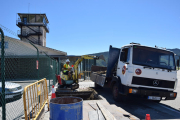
xmin=0 ymin=28 xmax=6 ymax=120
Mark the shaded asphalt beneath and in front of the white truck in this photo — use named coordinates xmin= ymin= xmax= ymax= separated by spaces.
xmin=96 ymin=71 xmax=180 ymax=119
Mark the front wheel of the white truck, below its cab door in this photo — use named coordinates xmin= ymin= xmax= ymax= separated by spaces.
xmin=112 ymin=84 xmax=122 ymax=102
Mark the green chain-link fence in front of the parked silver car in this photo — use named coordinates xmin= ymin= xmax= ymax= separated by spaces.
xmin=0 ymin=29 xmax=59 ymax=120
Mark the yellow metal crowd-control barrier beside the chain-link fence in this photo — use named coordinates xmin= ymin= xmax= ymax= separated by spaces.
xmin=23 ymin=78 xmax=49 ymax=120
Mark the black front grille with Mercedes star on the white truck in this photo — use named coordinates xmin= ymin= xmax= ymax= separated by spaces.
xmin=132 ymin=76 xmax=175 ymax=89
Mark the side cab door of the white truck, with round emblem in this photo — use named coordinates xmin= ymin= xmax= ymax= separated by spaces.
xmin=117 ymin=48 xmax=131 ymax=85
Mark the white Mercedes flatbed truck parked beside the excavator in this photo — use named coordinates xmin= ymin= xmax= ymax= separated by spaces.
xmin=91 ymin=43 xmax=178 ymax=102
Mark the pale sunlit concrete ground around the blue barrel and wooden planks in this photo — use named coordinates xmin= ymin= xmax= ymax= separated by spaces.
xmin=40 ymin=80 xmax=139 ymax=120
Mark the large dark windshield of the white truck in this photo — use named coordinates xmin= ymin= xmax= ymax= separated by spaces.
xmin=133 ymin=46 xmax=176 ymax=70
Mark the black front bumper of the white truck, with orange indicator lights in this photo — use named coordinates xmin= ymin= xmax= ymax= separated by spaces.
xmin=122 ymin=87 xmax=177 ymax=100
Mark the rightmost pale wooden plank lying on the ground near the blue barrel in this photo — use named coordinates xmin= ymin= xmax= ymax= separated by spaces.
xmin=97 ymin=101 xmax=116 ymax=120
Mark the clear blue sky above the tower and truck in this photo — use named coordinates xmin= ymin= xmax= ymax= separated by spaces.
xmin=0 ymin=0 xmax=180 ymax=55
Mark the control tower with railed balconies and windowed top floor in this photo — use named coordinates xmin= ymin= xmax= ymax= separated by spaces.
xmin=16 ymin=13 xmax=49 ymax=47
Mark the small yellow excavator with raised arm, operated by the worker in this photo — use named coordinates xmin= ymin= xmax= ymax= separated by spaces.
xmin=58 ymin=55 xmax=105 ymax=90
